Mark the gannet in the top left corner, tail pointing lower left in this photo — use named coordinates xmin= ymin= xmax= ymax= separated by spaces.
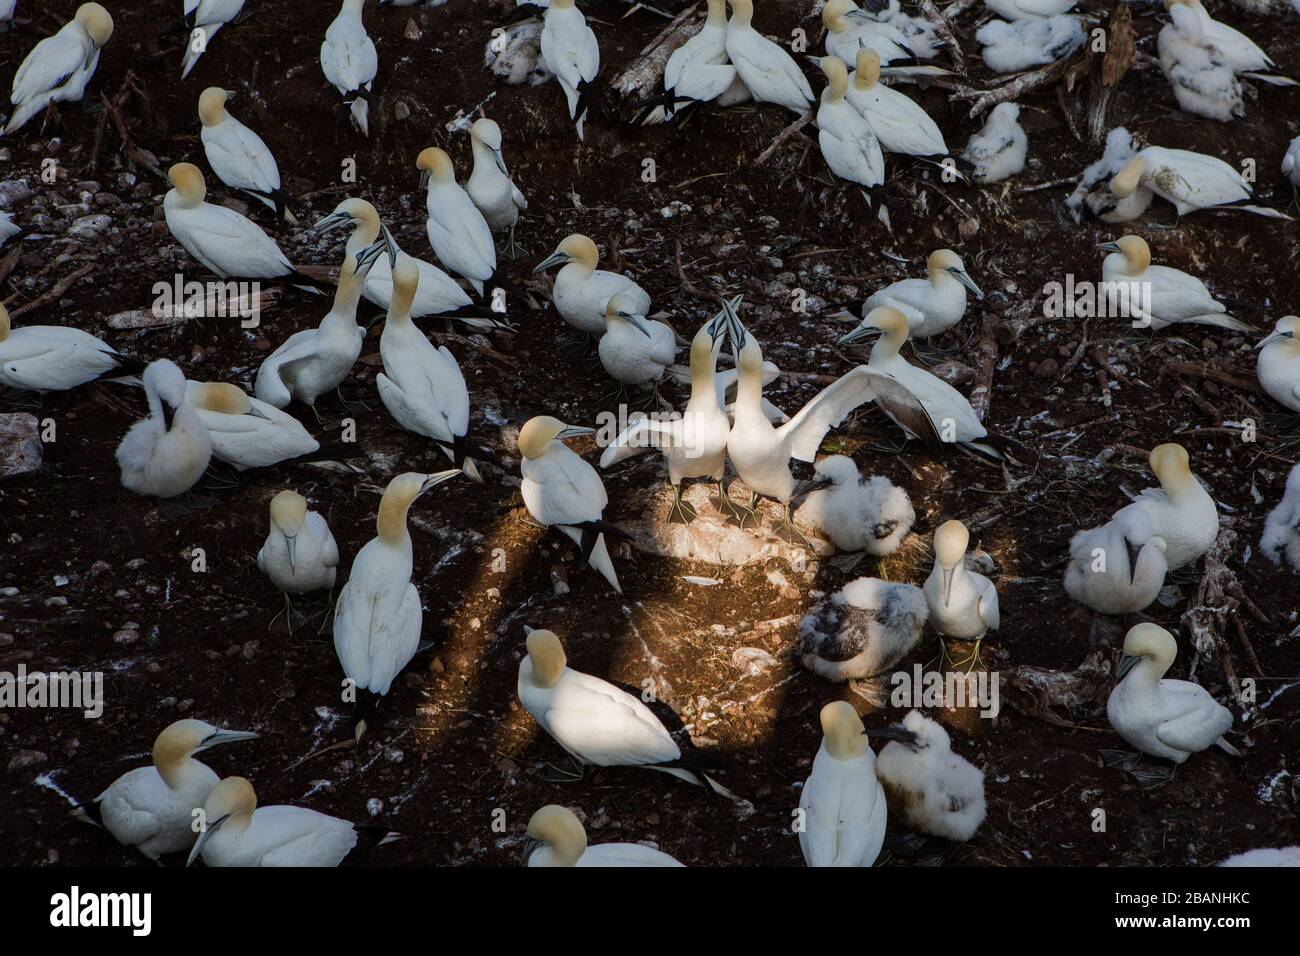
xmin=4 ymin=4 xmax=113 ymax=135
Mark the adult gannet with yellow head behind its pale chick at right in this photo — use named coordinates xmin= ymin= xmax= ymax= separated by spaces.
xmin=1115 ymin=442 xmax=1218 ymax=571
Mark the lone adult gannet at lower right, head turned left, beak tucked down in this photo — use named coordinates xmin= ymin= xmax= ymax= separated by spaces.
xmin=1106 ymin=623 xmax=1240 ymax=780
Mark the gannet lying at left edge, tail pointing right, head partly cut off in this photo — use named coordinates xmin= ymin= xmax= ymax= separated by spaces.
xmin=0 ymin=303 xmax=144 ymax=392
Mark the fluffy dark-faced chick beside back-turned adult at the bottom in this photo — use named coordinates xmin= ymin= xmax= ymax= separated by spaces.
xmin=876 ymin=710 xmax=988 ymax=843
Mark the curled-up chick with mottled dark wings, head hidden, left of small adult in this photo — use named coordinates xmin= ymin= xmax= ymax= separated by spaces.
xmin=798 ymin=578 xmax=930 ymax=683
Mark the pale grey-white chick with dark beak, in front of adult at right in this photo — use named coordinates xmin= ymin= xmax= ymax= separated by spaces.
xmin=1065 ymin=509 xmax=1169 ymax=614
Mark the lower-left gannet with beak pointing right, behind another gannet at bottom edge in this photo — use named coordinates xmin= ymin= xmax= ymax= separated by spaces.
xmin=78 ymin=719 xmax=257 ymax=860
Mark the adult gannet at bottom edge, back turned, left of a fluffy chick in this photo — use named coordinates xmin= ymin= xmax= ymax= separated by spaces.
xmin=800 ymin=701 xmax=889 ymax=866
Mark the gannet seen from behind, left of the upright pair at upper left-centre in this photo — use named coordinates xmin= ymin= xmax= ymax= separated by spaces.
xmin=415 ymin=146 xmax=497 ymax=295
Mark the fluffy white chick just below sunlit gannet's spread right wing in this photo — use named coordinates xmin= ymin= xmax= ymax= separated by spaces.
xmin=798 ymin=455 xmax=917 ymax=570
